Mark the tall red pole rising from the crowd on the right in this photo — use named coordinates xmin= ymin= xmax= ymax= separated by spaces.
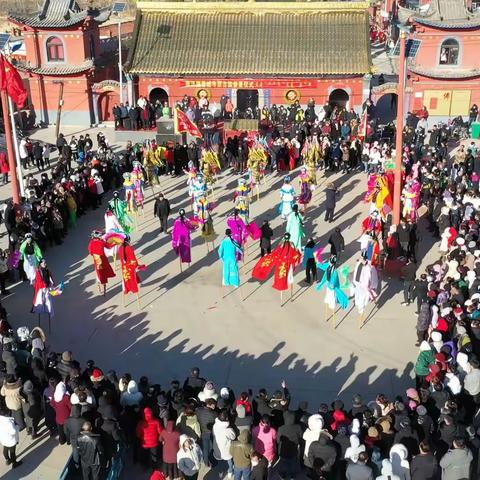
xmin=393 ymin=32 xmax=407 ymax=225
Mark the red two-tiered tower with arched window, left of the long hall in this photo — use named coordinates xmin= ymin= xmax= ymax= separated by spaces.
xmin=8 ymin=0 xmax=130 ymax=125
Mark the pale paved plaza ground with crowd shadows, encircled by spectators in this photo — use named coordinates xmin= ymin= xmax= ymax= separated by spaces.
xmin=0 ymin=126 xmax=450 ymax=479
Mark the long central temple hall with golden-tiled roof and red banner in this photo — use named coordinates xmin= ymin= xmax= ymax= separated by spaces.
xmin=125 ymin=1 xmax=371 ymax=114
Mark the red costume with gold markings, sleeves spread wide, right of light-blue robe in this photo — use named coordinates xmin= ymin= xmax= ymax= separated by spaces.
xmin=252 ymin=240 xmax=302 ymax=291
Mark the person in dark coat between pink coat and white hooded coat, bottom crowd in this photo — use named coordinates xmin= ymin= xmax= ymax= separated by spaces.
xmin=277 ymin=410 xmax=303 ymax=478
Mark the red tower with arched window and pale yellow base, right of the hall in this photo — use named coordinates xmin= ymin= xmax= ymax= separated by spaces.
xmin=372 ymin=0 xmax=480 ymax=119
